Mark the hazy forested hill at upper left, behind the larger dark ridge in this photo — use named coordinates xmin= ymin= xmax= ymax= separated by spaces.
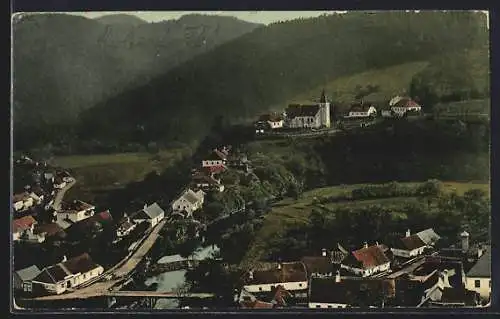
xmin=13 ymin=14 xmax=260 ymax=150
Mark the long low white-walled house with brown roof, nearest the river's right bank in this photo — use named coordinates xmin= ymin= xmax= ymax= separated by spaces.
xmin=243 ymin=262 xmax=308 ymax=293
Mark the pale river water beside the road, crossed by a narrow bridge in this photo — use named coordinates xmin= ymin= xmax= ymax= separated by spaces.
xmin=144 ymin=246 xmax=219 ymax=309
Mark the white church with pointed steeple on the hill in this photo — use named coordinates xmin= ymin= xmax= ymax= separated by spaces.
xmin=285 ymin=90 xmax=331 ymax=128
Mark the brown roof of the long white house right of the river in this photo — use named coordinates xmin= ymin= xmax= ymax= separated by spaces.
xmin=245 ymin=262 xmax=307 ymax=285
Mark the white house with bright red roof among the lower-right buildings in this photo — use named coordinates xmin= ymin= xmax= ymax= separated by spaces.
xmin=341 ymin=243 xmax=391 ymax=277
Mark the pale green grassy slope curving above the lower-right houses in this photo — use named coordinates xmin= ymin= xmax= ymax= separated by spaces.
xmin=242 ymin=182 xmax=490 ymax=266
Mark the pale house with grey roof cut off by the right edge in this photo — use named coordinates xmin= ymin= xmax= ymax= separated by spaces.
xmin=465 ymin=247 xmax=491 ymax=300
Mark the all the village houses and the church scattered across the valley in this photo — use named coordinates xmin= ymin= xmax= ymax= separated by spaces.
xmin=12 ymin=114 xmax=491 ymax=309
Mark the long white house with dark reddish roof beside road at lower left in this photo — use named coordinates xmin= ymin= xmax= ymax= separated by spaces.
xmin=32 ymin=253 xmax=104 ymax=294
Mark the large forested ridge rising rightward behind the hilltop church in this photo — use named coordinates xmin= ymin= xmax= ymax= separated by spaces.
xmin=74 ymin=12 xmax=488 ymax=149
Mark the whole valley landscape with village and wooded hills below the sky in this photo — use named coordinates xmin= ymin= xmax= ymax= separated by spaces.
xmin=10 ymin=10 xmax=493 ymax=312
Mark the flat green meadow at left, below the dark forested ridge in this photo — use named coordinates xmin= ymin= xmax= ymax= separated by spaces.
xmin=53 ymin=149 xmax=189 ymax=201
